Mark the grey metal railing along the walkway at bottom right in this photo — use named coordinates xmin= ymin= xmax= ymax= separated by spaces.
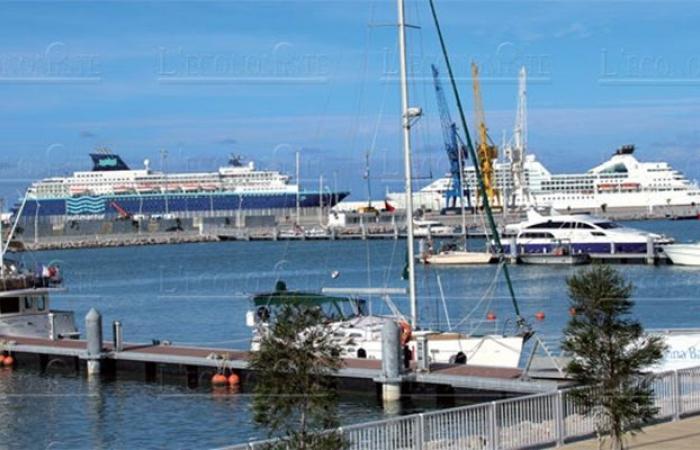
xmin=231 ymin=367 xmax=700 ymax=450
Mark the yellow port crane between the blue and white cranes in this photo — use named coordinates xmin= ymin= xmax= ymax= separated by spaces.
xmin=472 ymin=62 xmax=503 ymax=207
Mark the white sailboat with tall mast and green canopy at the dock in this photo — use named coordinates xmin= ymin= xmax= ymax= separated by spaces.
xmin=246 ymin=0 xmax=526 ymax=368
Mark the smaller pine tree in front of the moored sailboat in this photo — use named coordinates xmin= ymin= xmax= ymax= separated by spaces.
xmin=249 ymin=305 xmax=344 ymax=450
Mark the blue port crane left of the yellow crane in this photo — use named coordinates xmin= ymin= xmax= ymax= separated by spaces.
xmin=431 ymin=65 xmax=471 ymax=210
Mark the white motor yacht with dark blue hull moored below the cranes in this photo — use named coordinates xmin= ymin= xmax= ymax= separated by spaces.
xmin=504 ymin=211 xmax=673 ymax=254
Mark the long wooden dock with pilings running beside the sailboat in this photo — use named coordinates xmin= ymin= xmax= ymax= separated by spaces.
xmin=0 ymin=336 xmax=560 ymax=396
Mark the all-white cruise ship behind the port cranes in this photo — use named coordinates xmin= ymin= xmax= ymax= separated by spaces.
xmin=388 ymin=145 xmax=700 ymax=213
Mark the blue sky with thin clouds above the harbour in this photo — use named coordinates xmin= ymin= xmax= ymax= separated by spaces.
xmin=0 ymin=0 xmax=700 ymax=203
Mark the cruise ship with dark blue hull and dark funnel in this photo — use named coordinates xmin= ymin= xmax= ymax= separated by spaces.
xmin=13 ymin=151 xmax=349 ymax=222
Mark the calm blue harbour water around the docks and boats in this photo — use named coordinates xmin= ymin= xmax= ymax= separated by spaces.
xmin=0 ymin=221 xmax=700 ymax=448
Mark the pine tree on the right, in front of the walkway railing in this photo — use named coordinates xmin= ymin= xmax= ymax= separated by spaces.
xmin=563 ymin=265 xmax=666 ymax=450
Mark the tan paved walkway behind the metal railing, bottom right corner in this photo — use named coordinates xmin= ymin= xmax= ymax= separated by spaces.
xmin=561 ymin=416 xmax=700 ymax=450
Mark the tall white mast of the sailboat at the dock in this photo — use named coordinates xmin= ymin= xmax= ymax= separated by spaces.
xmin=398 ymin=0 xmax=420 ymax=328
